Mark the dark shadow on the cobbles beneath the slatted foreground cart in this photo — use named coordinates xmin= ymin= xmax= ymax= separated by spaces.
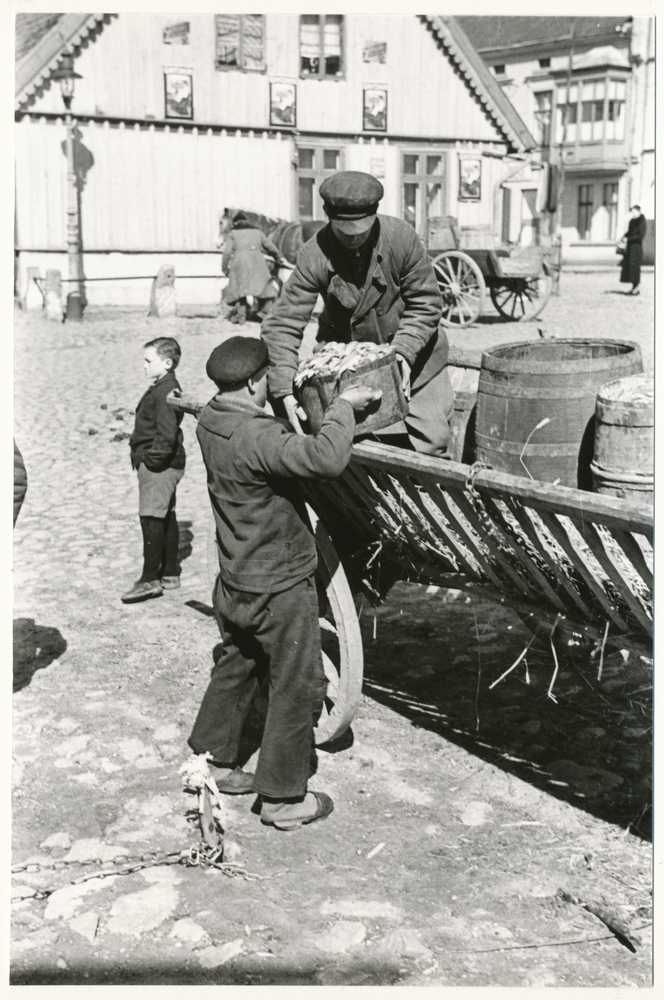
xmin=361 ymin=583 xmax=652 ymax=839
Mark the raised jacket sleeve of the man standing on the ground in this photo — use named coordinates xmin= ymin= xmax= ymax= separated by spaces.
xmin=258 ymin=399 xmax=355 ymax=479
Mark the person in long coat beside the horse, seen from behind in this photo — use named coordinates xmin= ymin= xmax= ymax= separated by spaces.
xmin=223 ymin=212 xmax=283 ymax=323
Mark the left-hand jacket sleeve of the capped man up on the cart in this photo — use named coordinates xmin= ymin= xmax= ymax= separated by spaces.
xmin=261 ymin=251 xmax=324 ymax=399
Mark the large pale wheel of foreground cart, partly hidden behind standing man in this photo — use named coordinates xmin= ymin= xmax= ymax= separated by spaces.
xmin=207 ymin=504 xmax=364 ymax=745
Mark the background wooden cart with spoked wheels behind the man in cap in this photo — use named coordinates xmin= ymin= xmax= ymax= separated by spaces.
xmin=428 ymin=216 xmax=553 ymax=327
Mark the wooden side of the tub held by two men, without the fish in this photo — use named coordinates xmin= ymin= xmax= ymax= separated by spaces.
xmin=298 ymin=351 xmax=408 ymax=437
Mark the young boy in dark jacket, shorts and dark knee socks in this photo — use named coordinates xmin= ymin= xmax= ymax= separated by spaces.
xmin=120 ymin=337 xmax=185 ymax=604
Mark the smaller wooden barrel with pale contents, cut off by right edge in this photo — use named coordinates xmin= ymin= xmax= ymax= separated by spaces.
xmin=590 ymin=375 xmax=655 ymax=506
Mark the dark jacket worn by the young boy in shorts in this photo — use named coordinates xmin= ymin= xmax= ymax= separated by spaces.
xmin=129 ymin=372 xmax=185 ymax=472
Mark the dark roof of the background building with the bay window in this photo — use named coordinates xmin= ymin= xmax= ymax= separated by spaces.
xmin=457 ymin=16 xmax=628 ymax=52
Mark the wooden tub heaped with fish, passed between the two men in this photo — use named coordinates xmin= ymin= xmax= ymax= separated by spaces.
xmin=293 ymin=341 xmax=408 ymax=437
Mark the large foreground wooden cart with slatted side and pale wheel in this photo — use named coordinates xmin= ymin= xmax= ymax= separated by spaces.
xmin=170 ymin=386 xmax=653 ymax=745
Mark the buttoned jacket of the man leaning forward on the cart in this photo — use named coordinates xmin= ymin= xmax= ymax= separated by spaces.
xmin=261 ymin=215 xmax=448 ymax=399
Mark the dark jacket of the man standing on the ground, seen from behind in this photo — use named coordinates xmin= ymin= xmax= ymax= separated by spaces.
xmin=196 ymin=395 xmax=355 ymax=593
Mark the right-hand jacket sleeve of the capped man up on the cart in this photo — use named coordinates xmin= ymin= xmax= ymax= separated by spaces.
xmin=392 ymin=230 xmax=443 ymax=367
